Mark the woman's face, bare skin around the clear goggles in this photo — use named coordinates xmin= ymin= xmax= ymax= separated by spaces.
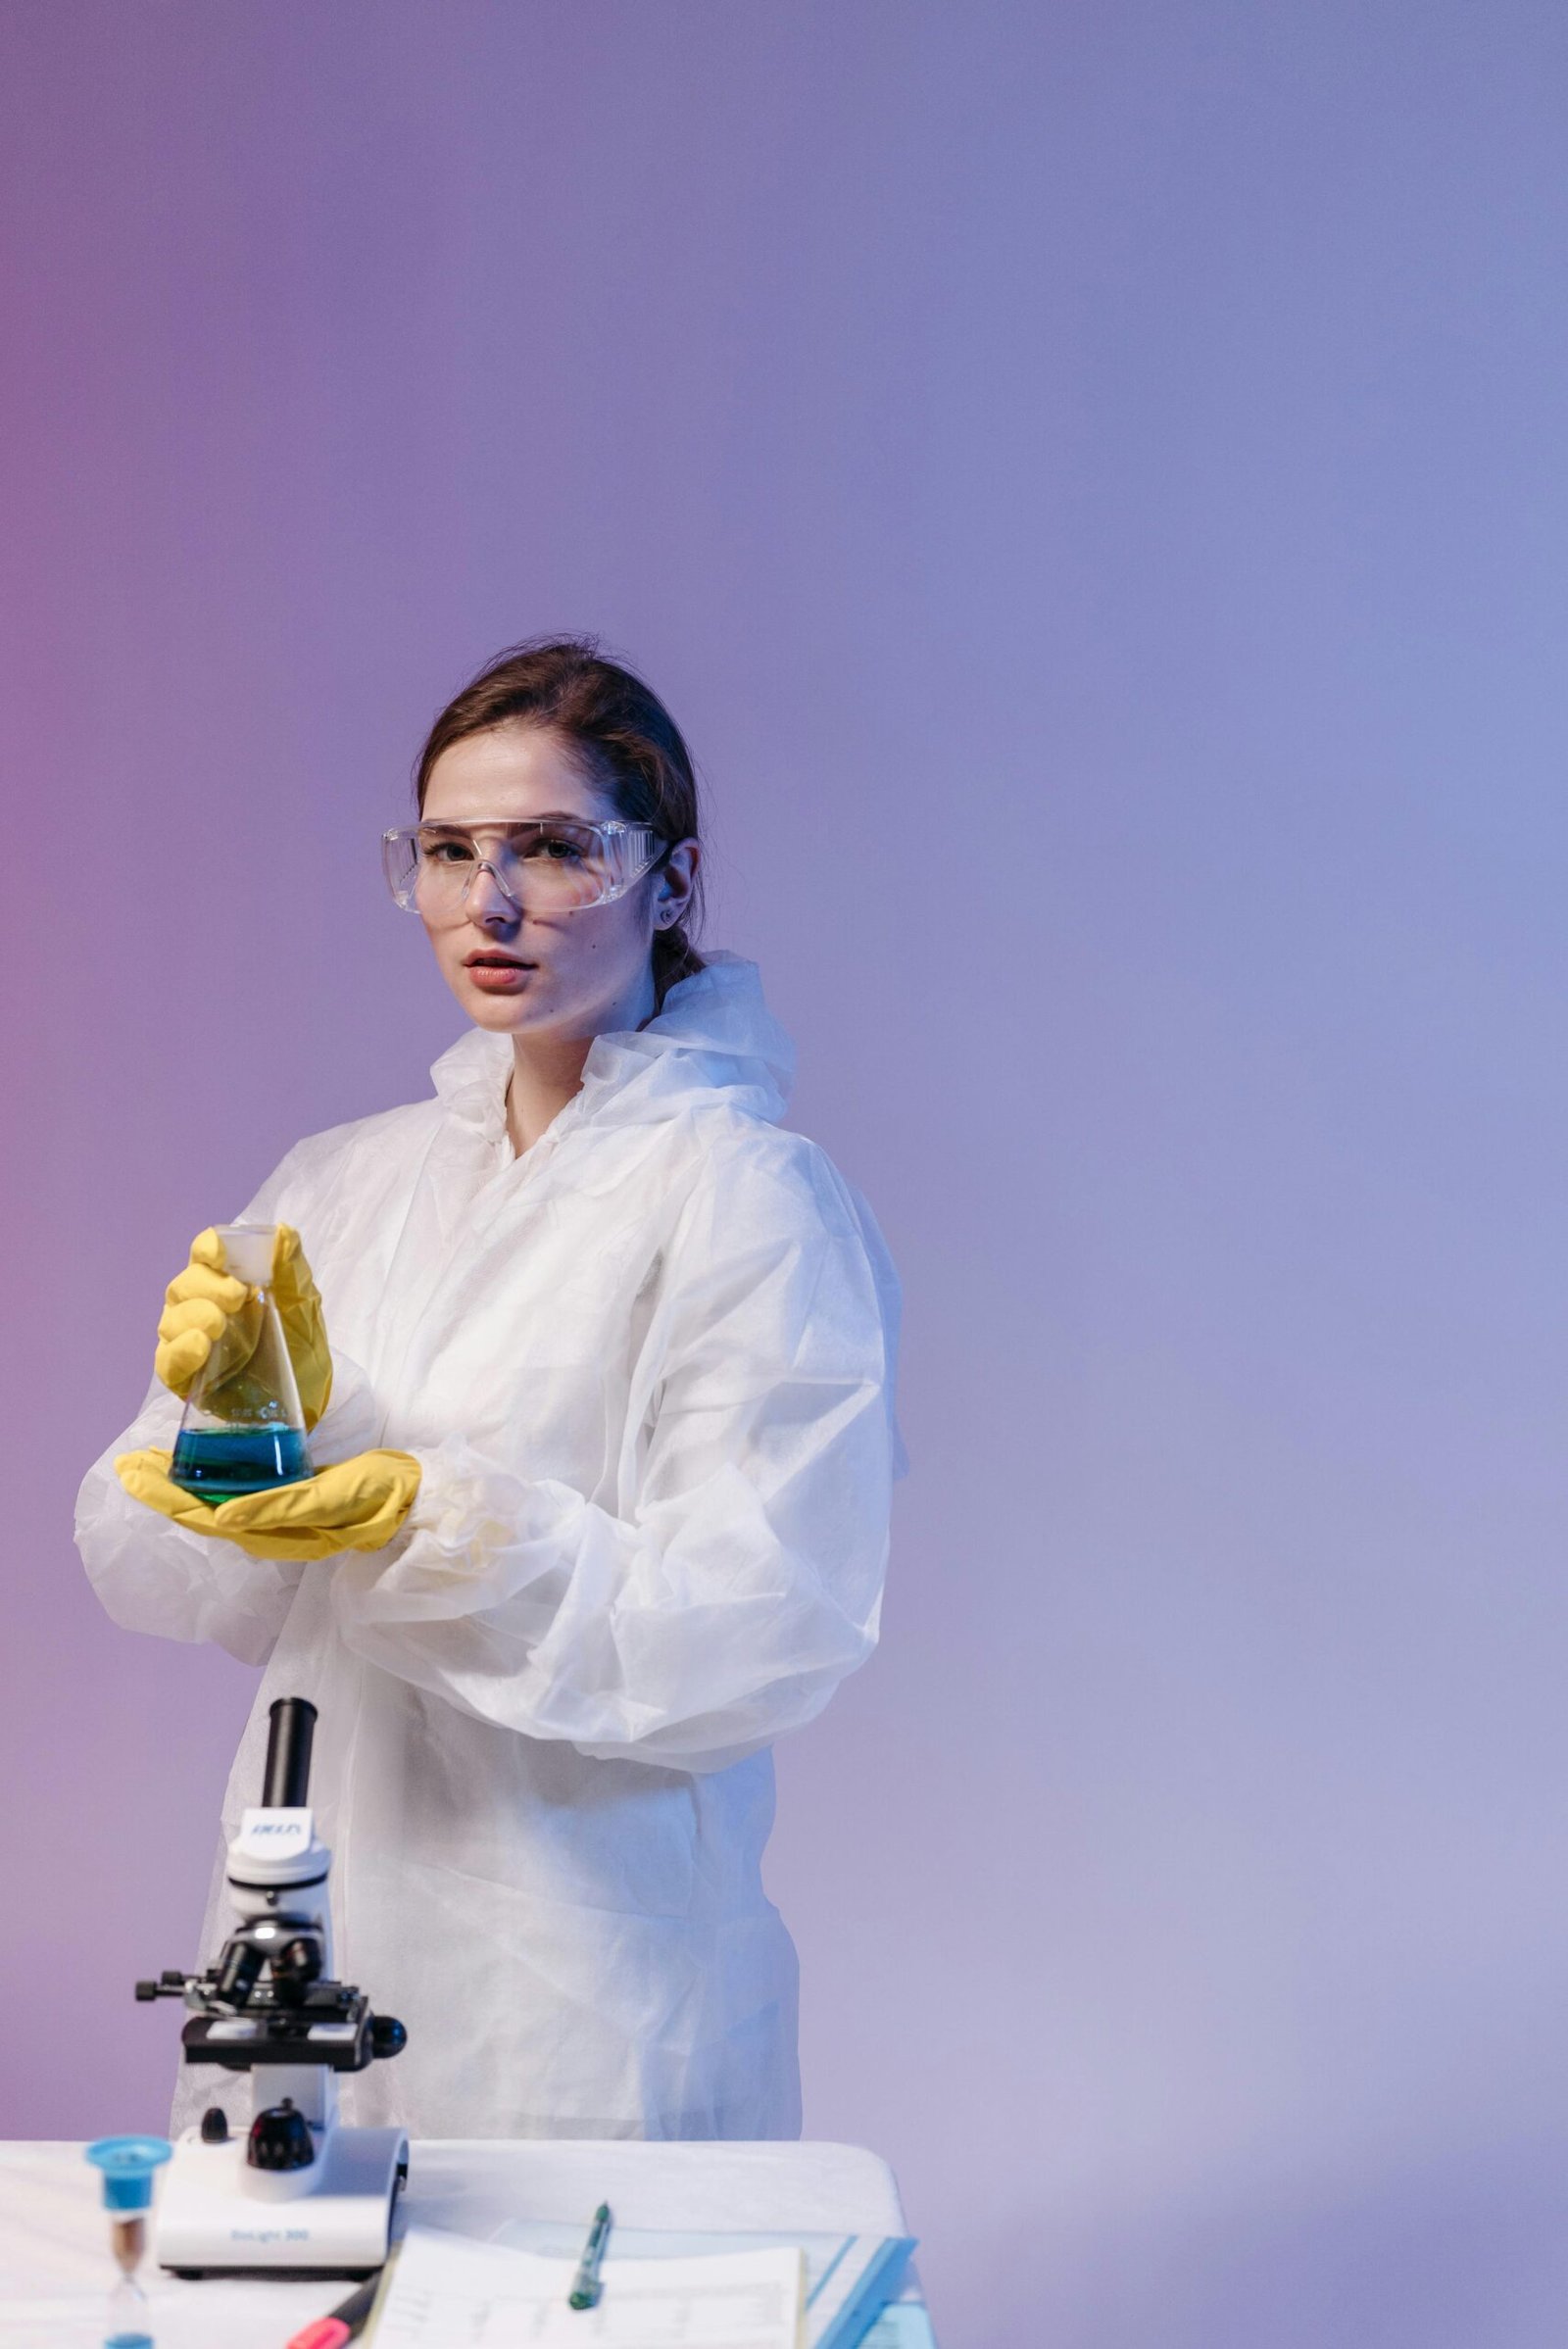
xmin=420 ymin=723 xmax=697 ymax=1043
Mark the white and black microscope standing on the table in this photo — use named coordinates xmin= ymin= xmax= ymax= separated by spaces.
xmin=136 ymin=1696 xmax=409 ymax=2276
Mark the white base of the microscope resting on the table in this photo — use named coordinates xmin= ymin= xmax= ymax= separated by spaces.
xmin=153 ymin=2126 xmax=409 ymax=2276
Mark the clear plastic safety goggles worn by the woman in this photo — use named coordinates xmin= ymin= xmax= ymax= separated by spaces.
xmin=380 ymin=815 xmax=664 ymax=921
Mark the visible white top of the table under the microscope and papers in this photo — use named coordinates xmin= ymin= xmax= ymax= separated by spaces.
xmin=0 ymin=2137 xmax=906 ymax=2349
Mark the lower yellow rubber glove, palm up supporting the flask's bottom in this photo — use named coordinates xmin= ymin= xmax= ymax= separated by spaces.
xmin=115 ymin=1447 xmax=420 ymax=1557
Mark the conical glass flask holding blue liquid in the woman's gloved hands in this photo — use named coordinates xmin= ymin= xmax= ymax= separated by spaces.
xmin=169 ymin=1224 xmax=313 ymax=1503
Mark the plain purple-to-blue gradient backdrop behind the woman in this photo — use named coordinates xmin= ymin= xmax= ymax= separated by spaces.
xmin=0 ymin=0 xmax=1568 ymax=2349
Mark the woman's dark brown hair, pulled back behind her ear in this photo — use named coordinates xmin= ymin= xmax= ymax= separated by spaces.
xmin=414 ymin=637 xmax=702 ymax=1005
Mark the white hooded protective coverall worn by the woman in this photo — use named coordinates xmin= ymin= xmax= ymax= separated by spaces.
xmin=77 ymin=956 xmax=899 ymax=2137
